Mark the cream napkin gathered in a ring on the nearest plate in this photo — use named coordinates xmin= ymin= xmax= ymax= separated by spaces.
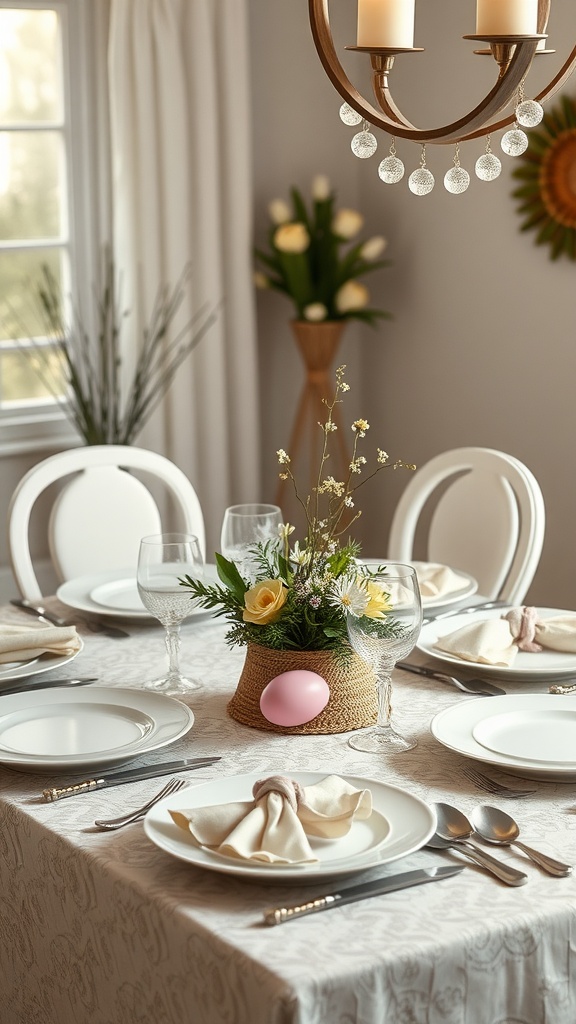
xmin=169 ymin=775 xmax=372 ymax=864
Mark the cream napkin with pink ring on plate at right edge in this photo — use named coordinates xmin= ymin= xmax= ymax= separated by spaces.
xmin=434 ymin=607 xmax=576 ymax=668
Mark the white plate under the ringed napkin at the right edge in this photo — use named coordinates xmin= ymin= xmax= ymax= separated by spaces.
xmin=416 ymin=605 xmax=576 ymax=682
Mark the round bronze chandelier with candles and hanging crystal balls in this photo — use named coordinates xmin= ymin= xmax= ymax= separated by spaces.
xmin=308 ymin=0 xmax=576 ymax=196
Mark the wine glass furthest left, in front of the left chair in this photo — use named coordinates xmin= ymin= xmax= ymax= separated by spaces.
xmin=137 ymin=534 xmax=204 ymax=693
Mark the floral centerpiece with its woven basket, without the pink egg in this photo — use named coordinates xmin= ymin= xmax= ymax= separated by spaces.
xmin=181 ymin=367 xmax=415 ymax=732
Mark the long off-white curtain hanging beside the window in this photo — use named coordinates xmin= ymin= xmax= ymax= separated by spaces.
xmin=109 ymin=0 xmax=259 ymax=552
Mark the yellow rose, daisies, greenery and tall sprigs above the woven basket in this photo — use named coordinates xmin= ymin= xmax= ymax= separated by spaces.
xmin=181 ymin=366 xmax=415 ymax=657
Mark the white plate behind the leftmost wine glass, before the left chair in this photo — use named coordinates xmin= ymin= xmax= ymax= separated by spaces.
xmin=56 ymin=563 xmax=218 ymax=622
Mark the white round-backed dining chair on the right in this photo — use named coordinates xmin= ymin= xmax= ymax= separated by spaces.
xmin=387 ymin=447 xmax=545 ymax=604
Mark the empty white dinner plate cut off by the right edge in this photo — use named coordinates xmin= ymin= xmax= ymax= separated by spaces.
xmin=430 ymin=693 xmax=576 ymax=781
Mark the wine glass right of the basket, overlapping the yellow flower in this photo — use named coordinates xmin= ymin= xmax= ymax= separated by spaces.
xmin=346 ymin=562 xmax=422 ymax=752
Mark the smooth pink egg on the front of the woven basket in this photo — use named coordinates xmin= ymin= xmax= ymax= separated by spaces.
xmin=260 ymin=669 xmax=330 ymax=726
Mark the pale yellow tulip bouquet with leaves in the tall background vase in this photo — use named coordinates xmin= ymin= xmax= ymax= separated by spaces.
xmin=254 ymin=175 xmax=390 ymax=326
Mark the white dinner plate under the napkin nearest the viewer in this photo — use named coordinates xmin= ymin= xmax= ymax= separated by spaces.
xmin=145 ymin=769 xmax=436 ymax=883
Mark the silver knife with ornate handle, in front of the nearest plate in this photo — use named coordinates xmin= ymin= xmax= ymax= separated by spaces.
xmin=264 ymin=864 xmax=463 ymax=925
